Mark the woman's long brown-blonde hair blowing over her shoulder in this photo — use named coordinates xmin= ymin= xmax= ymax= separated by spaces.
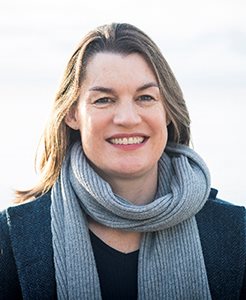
xmin=16 ymin=23 xmax=190 ymax=202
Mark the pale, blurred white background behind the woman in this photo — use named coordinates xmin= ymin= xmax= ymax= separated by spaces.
xmin=0 ymin=0 xmax=246 ymax=209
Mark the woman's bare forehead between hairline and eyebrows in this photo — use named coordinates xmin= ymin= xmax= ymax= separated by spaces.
xmin=82 ymin=52 xmax=157 ymax=87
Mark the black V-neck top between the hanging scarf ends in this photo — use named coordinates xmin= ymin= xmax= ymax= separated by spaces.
xmin=90 ymin=231 xmax=139 ymax=300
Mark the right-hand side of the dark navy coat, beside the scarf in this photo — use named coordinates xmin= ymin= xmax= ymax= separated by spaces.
xmin=196 ymin=189 xmax=246 ymax=299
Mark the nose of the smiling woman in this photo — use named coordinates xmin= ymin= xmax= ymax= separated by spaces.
xmin=113 ymin=100 xmax=141 ymax=127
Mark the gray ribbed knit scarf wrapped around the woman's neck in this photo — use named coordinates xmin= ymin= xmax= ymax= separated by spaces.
xmin=51 ymin=143 xmax=211 ymax=300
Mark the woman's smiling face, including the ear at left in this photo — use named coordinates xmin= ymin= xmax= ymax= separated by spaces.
xmin=66 ymin=53 xmax=167 ymax=180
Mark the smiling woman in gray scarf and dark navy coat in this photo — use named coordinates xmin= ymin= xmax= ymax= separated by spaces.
xmin=0 ymin=24 xmax=245 ymax=299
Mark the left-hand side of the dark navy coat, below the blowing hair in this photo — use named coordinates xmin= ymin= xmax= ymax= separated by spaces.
xmin=0 ymin=193 xmax=55 ymax=299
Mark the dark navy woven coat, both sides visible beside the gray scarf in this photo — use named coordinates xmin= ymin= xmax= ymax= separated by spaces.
xmin=0 ymin=190 xmax=246 ymax=300
